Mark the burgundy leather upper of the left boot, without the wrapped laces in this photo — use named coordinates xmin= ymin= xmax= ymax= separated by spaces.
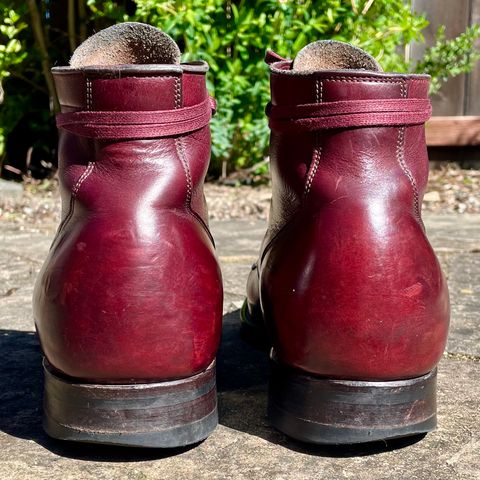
xmin=34 ymin=64 xmax=223 ymax=383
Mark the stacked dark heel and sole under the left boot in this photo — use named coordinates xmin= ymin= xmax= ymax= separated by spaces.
xmin=43 ymin=361 xmax=218 ymax=448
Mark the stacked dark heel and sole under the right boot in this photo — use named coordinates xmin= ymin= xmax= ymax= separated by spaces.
xmin=268 ymin=360 xmax=437 ymax=445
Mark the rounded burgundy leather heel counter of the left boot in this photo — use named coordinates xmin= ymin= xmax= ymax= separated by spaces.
xmin=34 ymin=211 xmax=223 ymax=381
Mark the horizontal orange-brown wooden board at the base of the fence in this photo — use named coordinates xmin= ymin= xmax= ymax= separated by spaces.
xmin=425 ymin=116 xmax=480 ymax=147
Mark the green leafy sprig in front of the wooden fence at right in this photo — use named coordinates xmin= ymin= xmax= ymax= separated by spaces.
xmin=414 ymin=24 xmax=480 ymax=93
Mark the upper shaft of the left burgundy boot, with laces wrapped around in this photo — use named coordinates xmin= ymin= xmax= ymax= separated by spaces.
xmin=53 ymin=62 xmax=212 ymax=228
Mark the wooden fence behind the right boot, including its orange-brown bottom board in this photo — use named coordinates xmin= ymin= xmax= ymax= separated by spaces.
xmin=410 ymin=0 xmax=480 ymax=146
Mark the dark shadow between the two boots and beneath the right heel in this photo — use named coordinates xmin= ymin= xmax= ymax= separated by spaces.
xmin=217 ymin=310 xmax=425 ymax=458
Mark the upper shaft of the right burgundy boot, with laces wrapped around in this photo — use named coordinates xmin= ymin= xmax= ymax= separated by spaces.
xmin=270 ymin=61 xmax=430 ymax=229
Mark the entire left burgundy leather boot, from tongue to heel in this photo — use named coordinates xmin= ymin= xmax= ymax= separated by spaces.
xmin=34 ymin=23 xmax=222 ymax=447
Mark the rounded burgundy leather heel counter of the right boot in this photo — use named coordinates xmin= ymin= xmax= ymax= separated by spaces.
xmin=261 ymin=211 xmax=449 ymax=379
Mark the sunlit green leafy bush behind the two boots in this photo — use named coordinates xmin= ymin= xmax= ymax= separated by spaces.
xmin=0 ymin=0 xmax=480 ymax=175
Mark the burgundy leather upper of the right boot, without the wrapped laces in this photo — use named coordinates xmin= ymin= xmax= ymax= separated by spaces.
xmin=247 ymin=61 xmax=449 ymax=380
